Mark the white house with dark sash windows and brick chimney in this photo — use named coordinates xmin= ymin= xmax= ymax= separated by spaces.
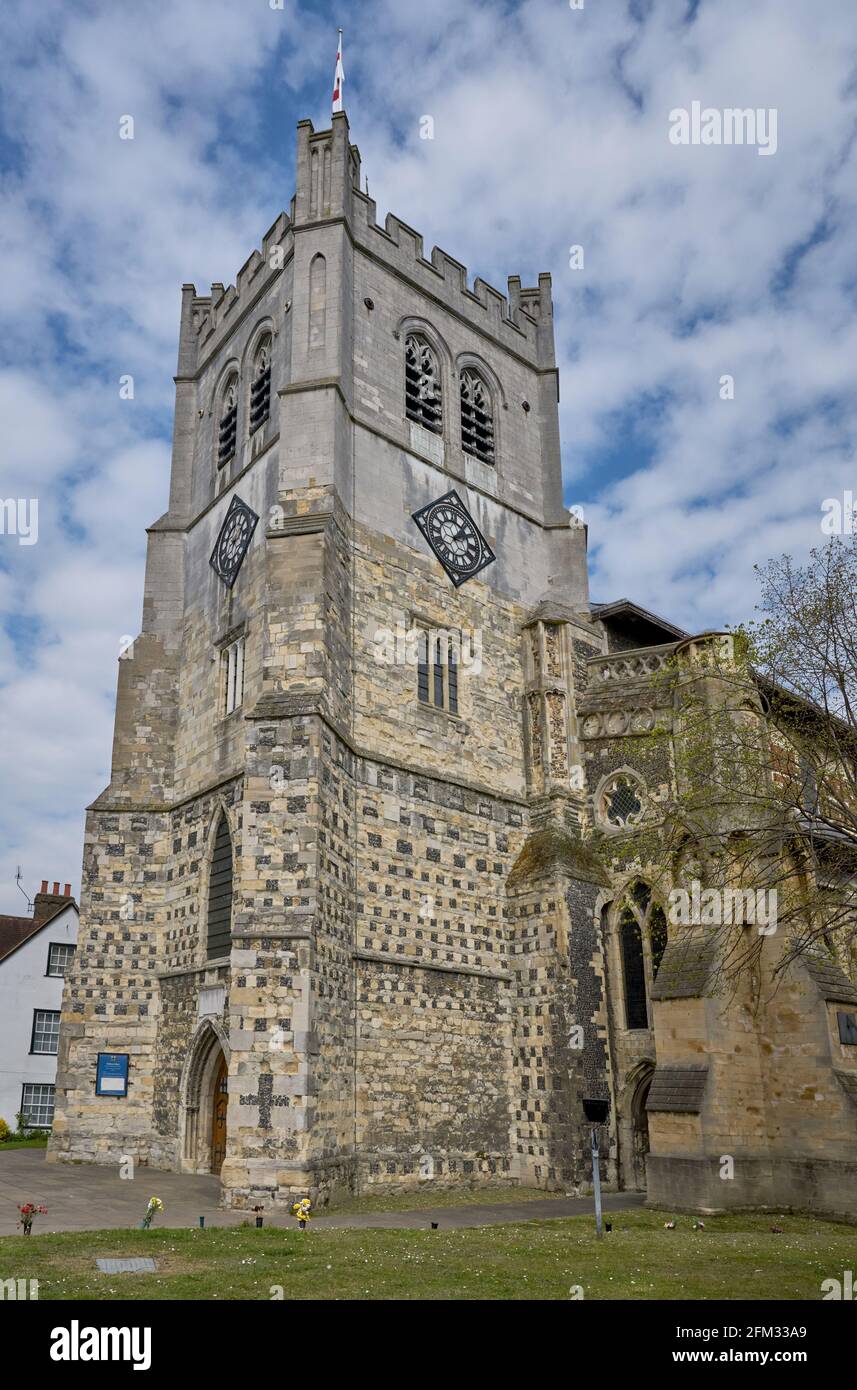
xmin=0 ymin=880 xmax=78 ymax=1129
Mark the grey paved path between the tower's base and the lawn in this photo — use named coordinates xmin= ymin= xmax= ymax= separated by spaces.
xmin=0 ymin=1148 xmax=644 ymax=1236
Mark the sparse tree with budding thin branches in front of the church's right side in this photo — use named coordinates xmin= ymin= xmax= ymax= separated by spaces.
xmin=594 ymin=538 xmax=857 ymax=984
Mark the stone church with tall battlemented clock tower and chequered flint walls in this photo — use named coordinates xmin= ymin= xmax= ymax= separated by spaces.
xmin=49 ymin=114 xmax=857 ymax=1215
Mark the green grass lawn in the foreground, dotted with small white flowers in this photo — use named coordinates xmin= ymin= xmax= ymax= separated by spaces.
xmin=0 ymin=1211 xmax=857 ymax=1300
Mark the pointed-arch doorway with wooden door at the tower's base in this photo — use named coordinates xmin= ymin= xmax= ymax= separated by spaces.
xmin=179 ymin=1019 xmax=229 ymax=1173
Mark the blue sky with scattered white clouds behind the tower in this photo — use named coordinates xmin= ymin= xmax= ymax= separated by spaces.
xmin=0 ymin=0 xmax=857 ymax=913
